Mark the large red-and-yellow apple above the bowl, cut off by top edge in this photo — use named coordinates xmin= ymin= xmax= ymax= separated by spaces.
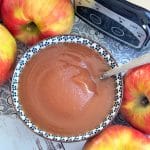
xmin=1 ymin=0 xmax=74 ymax=45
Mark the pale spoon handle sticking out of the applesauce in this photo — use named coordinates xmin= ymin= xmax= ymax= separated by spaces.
xmin=100 ymin=53 xmax=150 ymax=80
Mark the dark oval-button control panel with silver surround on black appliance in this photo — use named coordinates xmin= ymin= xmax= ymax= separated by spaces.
xmin=75 ymin=0 xmax=147 ymax=48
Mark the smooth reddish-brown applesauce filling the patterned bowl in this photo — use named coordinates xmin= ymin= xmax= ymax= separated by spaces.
xmin=19 ymin=43 xmax=115 ymax=136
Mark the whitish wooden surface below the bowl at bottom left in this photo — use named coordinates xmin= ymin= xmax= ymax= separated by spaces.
xmin=0 ymin=115 xmax=84 ymax=150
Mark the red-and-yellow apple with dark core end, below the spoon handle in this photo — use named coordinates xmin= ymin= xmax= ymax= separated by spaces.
xmin=121 ymin=63 xmax=150 ymax=134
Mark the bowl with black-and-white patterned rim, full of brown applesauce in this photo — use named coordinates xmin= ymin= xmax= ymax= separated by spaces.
xmin=11 ymin=35 xmax=123 ymax=142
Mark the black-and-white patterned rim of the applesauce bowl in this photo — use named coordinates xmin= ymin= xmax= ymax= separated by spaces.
xmin=11 ymin=35 xmax=123 ymax=142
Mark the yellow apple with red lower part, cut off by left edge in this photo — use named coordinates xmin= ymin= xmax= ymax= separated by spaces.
xmin=0 ymin=24 xmax=17 ymax=85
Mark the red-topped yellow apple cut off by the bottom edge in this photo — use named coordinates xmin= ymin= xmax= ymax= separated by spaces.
xmin=83 ymin=125 xmax=150 ymax=150
